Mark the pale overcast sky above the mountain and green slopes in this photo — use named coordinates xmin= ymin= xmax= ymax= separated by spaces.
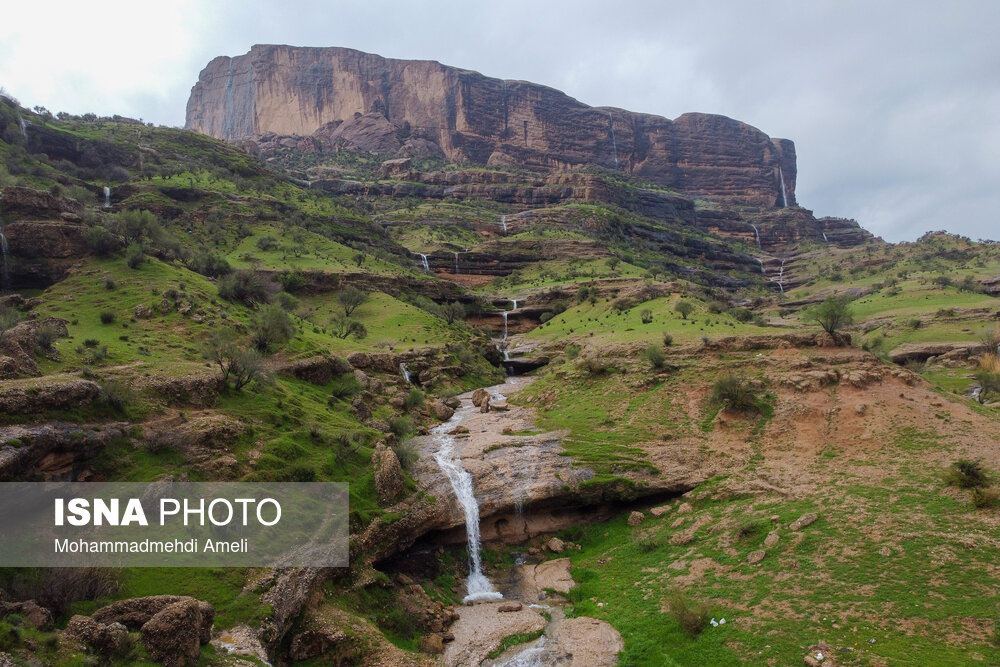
xmin=0 ymin=0 xmax=1000 ymax=241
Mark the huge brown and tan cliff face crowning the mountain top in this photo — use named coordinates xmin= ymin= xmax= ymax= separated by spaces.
xmin=187 ymin=45 xmax=796 ymax=207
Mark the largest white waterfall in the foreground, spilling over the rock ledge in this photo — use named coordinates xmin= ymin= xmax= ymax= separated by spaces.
xmin=431 ymin=406 xmax=503 ymax=602
